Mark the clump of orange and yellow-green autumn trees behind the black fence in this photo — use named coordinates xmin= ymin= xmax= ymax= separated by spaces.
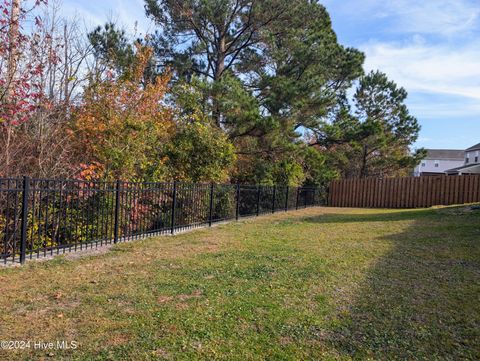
xmin=70 ymin=44 xmax=235 ymax=182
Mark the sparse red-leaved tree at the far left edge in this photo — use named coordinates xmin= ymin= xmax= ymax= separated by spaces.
xmin=0 ymin=0 xmax=44 ymax=175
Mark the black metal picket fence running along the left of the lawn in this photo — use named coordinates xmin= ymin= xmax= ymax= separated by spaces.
xmin=0 ymin=177 xmax=327 ymax=263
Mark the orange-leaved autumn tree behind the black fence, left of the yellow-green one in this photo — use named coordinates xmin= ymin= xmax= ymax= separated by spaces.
xmin=71 ymin=46 xmax=174 ymax=180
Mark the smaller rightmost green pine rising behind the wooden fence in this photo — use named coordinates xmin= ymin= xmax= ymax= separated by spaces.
xmin=319 ymin=71 xmax=424 ymax=177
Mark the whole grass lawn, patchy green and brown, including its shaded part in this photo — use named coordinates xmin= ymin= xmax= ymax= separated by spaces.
xmin=0 ymin=207 xmax=480 ymax=360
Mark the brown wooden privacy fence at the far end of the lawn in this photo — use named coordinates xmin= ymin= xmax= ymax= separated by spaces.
xmin=328 ymin=175 xmax=480 ymax=208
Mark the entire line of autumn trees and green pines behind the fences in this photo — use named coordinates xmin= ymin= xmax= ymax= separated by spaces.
xmin=0 ymin=0 xmax=423 ymax=185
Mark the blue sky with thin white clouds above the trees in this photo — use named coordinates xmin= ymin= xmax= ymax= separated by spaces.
xmin=62 ymin=0 xmax=480 ymax=149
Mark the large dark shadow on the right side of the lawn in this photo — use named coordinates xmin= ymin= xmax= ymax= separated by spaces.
xmin=306 ymin=207 xmax=480 ymax=360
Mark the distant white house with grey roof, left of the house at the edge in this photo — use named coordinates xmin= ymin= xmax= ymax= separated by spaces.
xmin=413 ymin=149 xmax=465 ymax=177
